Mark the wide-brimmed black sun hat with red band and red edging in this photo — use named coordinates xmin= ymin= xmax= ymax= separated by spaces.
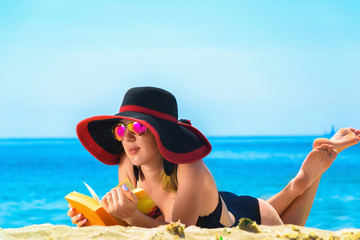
xmin=76 ymin=87 xmax=211 ymax=165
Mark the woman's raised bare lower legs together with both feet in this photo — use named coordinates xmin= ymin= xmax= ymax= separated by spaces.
xmin=268 ymin=128 xmax=360 ymax=225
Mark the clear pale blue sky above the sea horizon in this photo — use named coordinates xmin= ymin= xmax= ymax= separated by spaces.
xmin=0 ymin=0 xmax=360 ymax=138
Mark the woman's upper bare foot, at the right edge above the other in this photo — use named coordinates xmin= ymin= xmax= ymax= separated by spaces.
xmin=313 ymin=128 xmax=360 ymax=153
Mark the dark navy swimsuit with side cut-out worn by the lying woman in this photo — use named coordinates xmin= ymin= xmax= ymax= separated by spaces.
xmin=196 ymin=192 xmax=261 ymax=228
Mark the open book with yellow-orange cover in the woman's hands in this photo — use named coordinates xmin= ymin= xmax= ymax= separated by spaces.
xmin=65 ymin=178 xmax=161 ymax=226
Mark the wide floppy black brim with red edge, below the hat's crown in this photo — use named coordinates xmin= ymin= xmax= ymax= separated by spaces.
xmin=76 ymin=112 xmax=211 ymax=165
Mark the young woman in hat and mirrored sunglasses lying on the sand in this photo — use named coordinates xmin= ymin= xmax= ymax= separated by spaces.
xmin=68 ymin=87 xmax=360 ymax=228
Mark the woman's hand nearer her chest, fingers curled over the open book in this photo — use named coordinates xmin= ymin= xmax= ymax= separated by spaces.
xmin=101 ymin=185 xmax=139 ymax=225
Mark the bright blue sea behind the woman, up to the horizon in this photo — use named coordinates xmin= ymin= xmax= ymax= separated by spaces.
xmin=0 ymin=136 xmax=360 ymax=230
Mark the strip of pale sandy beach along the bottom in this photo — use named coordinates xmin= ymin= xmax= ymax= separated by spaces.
xmin=0 ymin=223 xmax=360 ymax=240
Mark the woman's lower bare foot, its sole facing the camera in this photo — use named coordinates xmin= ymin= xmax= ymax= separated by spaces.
xmin=292 ymin=144 xmax=337 ymax=195
